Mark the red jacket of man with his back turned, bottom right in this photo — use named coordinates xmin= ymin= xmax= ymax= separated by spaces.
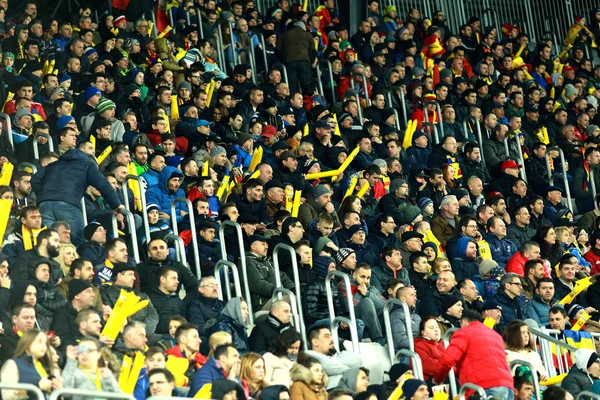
xmin=433 ymin=321 xmax=513 ymax=389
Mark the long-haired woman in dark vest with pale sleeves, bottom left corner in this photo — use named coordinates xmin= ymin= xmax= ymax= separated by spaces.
xmin=0 ymin=329 xmax=63 ymax=400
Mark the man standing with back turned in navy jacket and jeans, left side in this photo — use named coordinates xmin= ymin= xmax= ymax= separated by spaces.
xmin=31 ymin=149 xmax=123 ymax=246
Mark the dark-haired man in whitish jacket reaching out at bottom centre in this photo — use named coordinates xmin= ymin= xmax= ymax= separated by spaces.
xmin=306 ymin=325 xmax=362 ymax=388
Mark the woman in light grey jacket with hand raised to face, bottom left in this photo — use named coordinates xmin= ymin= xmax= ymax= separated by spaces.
xmin=63 ymin=338 xmax=121 ymax=400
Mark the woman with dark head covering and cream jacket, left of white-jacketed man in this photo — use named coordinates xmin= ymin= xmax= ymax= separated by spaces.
xmin=263 ymin=329 xmax=302 ymax=387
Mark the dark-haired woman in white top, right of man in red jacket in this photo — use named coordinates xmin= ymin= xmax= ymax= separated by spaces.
xmin=502 ymin=319 xmax=548 ymax=382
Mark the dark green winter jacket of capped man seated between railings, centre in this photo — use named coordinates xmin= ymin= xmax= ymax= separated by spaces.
xmin=246 ymin=252 xmax=294 ymax=310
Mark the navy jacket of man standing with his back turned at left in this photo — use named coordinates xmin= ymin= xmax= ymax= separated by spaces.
xmin=31 ymin=149 xmax=121 ymax=209
